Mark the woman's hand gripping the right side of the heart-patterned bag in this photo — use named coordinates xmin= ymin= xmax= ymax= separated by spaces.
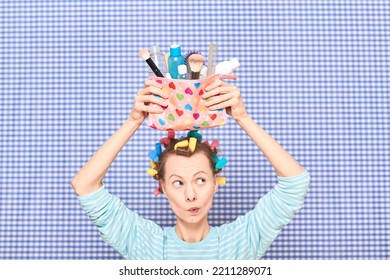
xmin=202 ymin=79 xmax=249 ymax=121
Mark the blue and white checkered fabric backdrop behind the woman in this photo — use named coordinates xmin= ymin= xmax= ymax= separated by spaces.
xmin=0 ymin=0 xmax=390 ymax=259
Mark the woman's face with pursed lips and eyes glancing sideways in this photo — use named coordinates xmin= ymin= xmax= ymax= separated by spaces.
xmin=161 ymin=152 xmax=218 ymax=223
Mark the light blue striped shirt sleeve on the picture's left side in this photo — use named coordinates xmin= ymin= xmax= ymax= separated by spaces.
xmin=77 ymin=184 xmax=162 ymax=259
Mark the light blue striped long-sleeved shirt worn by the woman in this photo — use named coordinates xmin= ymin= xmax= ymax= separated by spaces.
xmin=78 ymin=171 xmax=310 ymax=260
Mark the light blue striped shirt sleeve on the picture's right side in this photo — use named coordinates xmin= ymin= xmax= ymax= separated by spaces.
xmin=246 ymin=170 xmax=310 ymax=258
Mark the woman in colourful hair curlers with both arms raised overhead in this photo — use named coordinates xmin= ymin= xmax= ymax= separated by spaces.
xmin=71 ymin=79 xmax=310 ymax=259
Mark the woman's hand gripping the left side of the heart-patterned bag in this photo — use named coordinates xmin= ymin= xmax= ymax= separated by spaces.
xmin=129 ymin=80 xmax=168 ymax=124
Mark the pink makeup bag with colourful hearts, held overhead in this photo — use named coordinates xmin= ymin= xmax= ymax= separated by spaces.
xmin=147 ymin=75 xmax=236 ymax=131
